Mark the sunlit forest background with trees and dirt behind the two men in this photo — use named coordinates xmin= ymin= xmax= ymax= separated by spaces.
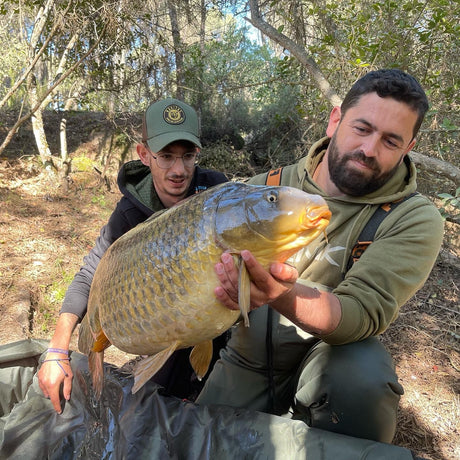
xmin=0 ymin=0 xmax=460 ymax=459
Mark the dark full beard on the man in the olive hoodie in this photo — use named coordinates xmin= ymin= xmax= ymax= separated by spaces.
xmin=328 ymin=134 xmax=400 ymax=196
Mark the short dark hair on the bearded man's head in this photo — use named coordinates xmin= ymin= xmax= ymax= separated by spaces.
xmin=340 ymin=69 xmax=428 ymax=137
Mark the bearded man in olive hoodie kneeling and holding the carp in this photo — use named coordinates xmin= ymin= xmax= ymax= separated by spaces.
xmin=197 ymin=70 xmax=443 ymax=443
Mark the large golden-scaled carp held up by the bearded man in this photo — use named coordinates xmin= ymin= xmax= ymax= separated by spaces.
xmin=78 ymin=182 xmax=331 ymax=397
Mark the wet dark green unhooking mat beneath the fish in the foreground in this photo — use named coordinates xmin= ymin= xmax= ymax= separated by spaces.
xmin=0 ymin=340 xmax=413 ymax=460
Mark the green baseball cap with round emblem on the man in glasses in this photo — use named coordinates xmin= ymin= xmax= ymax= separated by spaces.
xmin=142 ymin=97 xmax=201 ymax=153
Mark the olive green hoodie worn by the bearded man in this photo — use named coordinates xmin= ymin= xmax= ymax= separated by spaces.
xmin=250 ymin=138 xmax=443 ymax=344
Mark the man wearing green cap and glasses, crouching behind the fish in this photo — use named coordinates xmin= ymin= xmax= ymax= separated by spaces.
xmin=38 ymin=98 xmax=227 ymax=413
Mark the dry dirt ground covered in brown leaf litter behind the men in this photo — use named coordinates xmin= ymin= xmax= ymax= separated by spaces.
xmin=0 ymin=132 xmax=460 ymax=460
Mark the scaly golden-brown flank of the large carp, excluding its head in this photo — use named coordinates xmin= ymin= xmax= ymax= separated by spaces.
xmin=91 ymin=182 xmax=239 ymax=354
